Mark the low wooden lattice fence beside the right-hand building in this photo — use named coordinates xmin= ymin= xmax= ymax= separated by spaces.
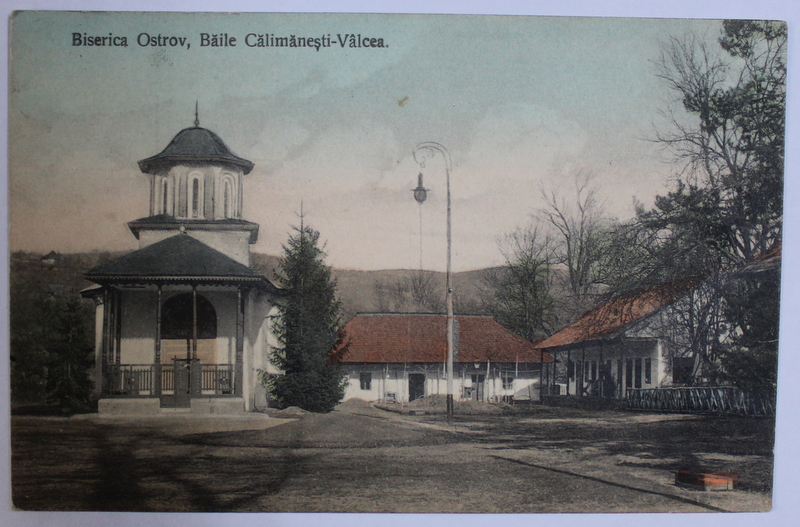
xmin=627 ymin=387 xmax=775 ymax=416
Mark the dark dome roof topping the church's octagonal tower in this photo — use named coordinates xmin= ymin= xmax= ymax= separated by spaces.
xmin=139 ymin=126 xmax=253 ymax=174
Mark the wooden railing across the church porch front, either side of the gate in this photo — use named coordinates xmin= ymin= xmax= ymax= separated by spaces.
xmin=103 ymin=364 xmax=235 ymax=397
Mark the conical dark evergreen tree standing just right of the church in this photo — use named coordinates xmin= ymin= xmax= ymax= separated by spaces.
xmin=266 ymin=225 xmax=346 ymax=412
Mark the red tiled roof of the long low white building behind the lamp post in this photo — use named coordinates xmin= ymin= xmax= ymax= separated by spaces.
xmin=332 ymin=313 xmax=553 ymax=363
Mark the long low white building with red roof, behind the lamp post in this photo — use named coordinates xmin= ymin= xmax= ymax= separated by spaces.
xmin=331 ymin=313 xmax=553 ymax=402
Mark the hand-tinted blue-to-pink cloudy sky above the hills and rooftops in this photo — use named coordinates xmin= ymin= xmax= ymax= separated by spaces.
xmin=1 ymin=13 xmax=776 ymax=270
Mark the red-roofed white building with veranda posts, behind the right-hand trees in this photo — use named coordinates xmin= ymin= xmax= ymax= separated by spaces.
xmin=538 ymin=248 xmax=781 ymax=398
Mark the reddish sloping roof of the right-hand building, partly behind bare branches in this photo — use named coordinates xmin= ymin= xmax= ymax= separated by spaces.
xmin=538 ymin=280 xmax=696 ymax=349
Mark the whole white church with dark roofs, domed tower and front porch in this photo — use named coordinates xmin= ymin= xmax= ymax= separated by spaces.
xmin=84 ymin=116 xmax=280 ymax=414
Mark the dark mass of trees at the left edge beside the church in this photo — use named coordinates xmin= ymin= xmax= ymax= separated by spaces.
xmin=10 ymin=280 xmax=94 ymax=413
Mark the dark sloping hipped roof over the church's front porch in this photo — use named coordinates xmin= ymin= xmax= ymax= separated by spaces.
xmin=85 ymin=233 xmax=277 ymax=291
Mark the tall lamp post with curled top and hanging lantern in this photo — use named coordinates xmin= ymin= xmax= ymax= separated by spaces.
xmin=412 ymin=142 xmax=453 ymax=421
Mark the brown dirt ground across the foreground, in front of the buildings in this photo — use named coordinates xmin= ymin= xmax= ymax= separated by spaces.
xmin=11 ymin=401 xmax=774 ymax=512
